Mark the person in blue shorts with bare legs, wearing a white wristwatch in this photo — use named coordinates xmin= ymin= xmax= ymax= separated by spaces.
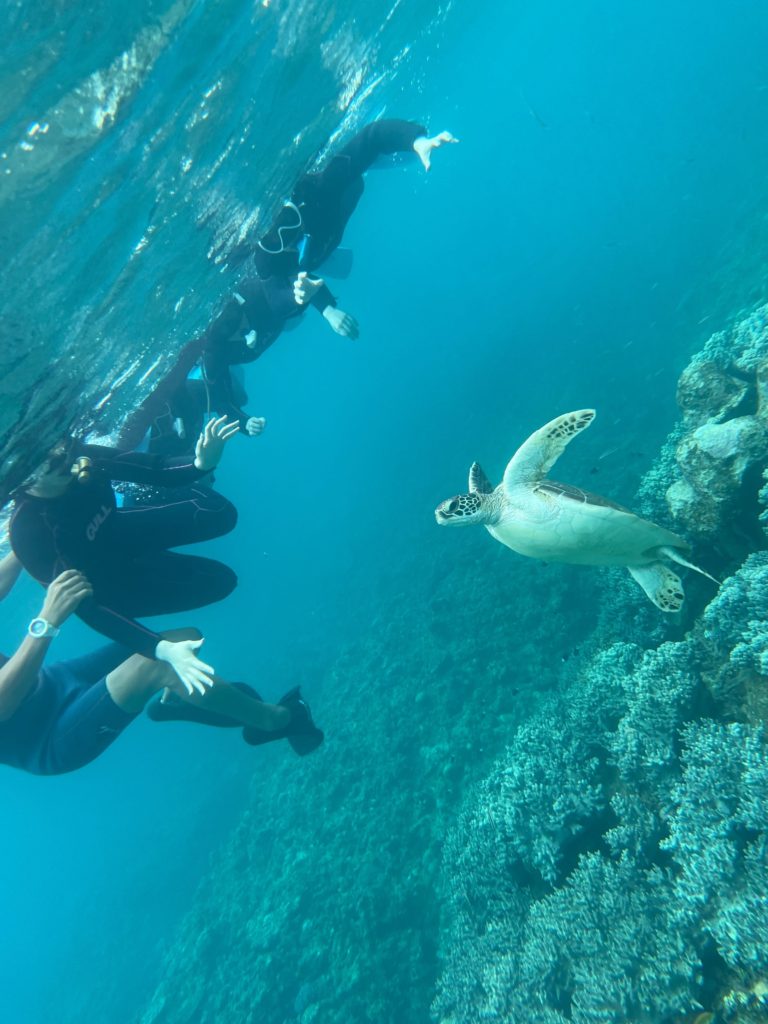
xmin=0 ymin=553 xmax=323 ymax=775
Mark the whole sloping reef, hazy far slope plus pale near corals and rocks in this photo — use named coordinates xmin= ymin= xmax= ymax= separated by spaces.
xmin=129 ymin=309 xmax=768 ymax=1024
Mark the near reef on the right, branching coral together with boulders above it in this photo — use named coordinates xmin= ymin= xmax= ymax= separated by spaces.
xmin=433 ymin=299 xmax=768 ymax=1024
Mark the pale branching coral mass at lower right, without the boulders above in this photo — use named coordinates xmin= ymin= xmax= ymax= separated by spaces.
xmin=433 ymin=555 xmax=768 ymax=1024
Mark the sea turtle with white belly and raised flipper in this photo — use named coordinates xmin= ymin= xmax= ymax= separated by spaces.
xmin=435 ymin=409 xmax=718 ymax=611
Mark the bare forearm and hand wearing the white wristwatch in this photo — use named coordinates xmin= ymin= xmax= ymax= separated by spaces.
xmin=0 ymin=559 xmax=91 ymax=722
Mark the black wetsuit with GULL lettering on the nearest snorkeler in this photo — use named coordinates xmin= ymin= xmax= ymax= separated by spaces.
xmin=10 ymin=445 xmax=238 ymax=657
